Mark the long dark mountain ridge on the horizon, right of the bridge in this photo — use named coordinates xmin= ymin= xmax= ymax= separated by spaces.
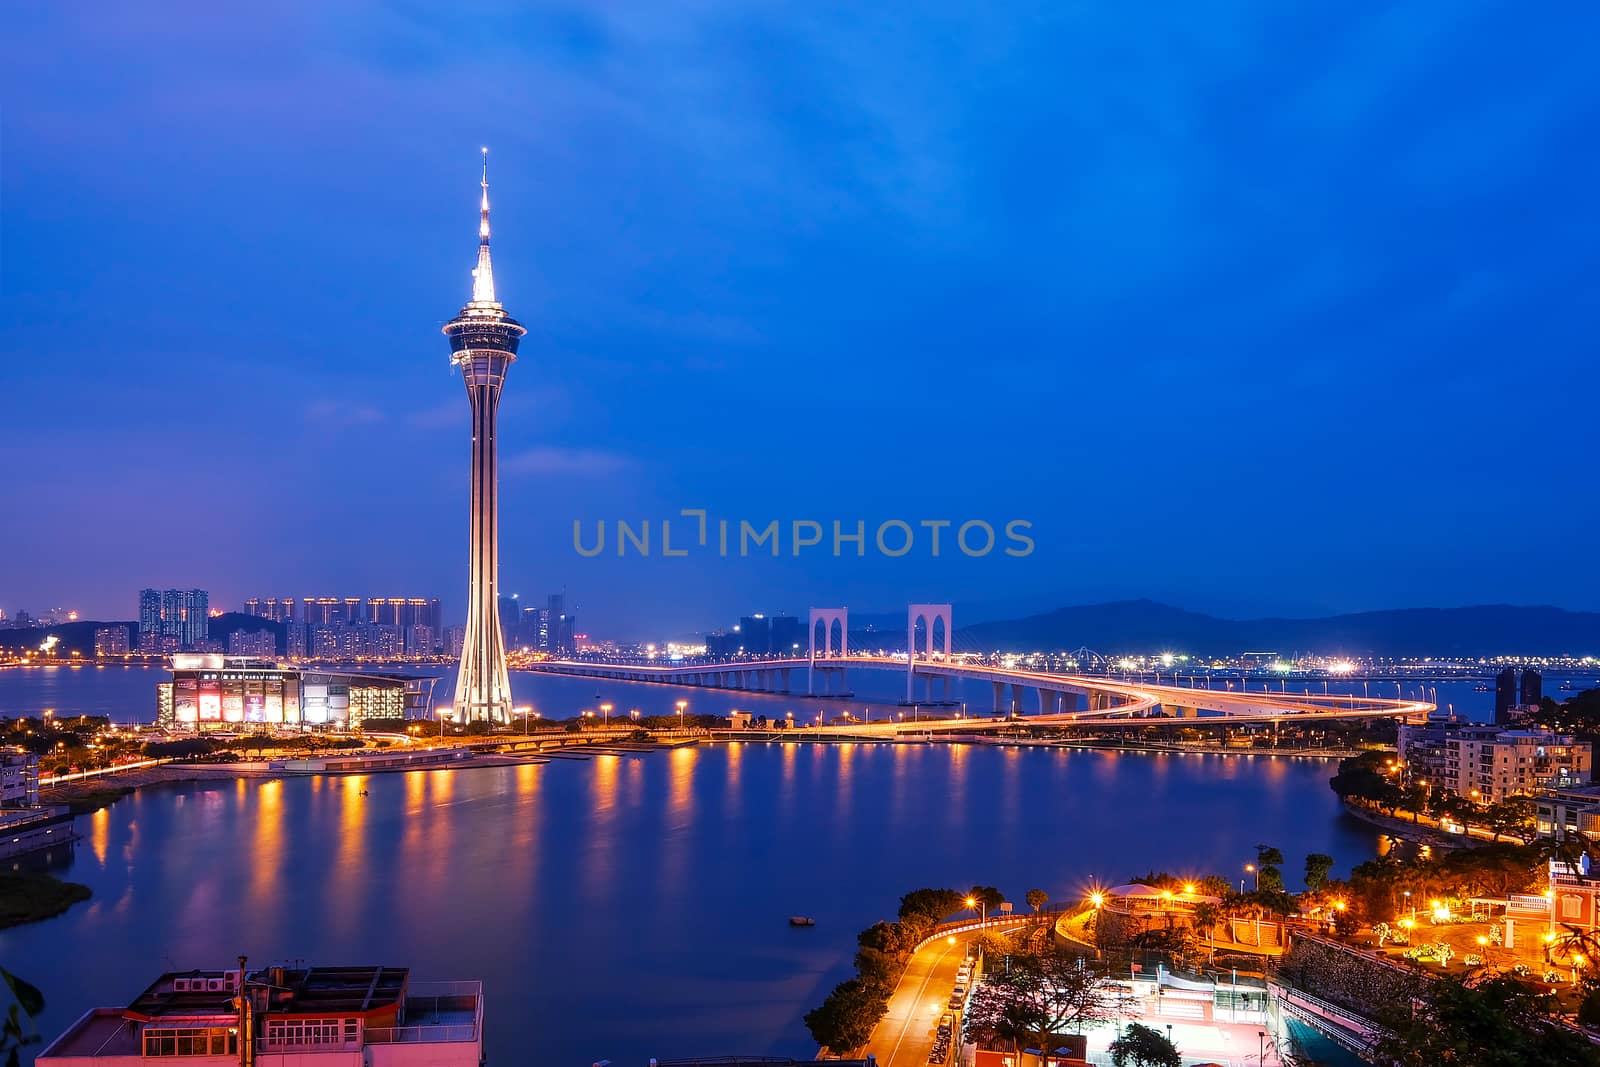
xmin=934 ymin=600 xmax=1600 ymax=656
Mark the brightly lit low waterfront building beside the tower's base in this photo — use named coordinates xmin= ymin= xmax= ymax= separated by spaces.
xmin=155 ymin=656 xmax=438 ymax=731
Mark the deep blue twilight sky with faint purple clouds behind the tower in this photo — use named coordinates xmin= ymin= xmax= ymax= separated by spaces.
xmin=0 ymin=0 xmax=1600 ymax=635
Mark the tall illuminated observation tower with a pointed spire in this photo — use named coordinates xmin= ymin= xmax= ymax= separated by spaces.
xmin=445 ymin=149 xmax=528 ymax=723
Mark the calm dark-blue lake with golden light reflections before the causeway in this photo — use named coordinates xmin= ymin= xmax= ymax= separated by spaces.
xmin=0 ymin=742 xmax=1395 ymax=1065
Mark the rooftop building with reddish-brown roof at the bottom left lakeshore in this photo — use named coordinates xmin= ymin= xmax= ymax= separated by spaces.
xmin=34 ymin=958 xmax=483 ymax=1067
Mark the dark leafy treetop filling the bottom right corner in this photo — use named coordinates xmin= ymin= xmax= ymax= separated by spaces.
xmin=1370 ymin=976 xmax=1600 ymax=1067
